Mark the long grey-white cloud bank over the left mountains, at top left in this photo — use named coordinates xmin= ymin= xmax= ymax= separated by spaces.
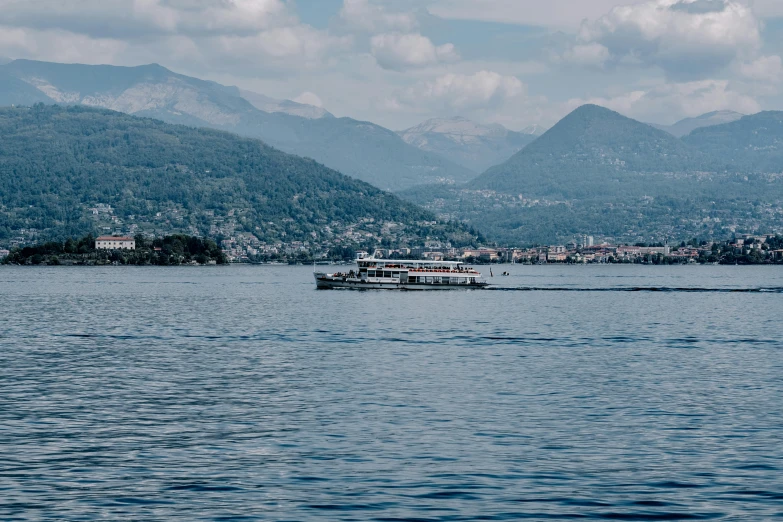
xmin=0 ymin=0 xmax=352 ymax=74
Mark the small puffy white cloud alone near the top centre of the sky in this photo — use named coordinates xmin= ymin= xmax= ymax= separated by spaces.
xmin=370 ymin=33 xmax=459 ymax=71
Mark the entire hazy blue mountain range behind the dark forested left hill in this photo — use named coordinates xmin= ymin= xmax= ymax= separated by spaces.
xmin=0 ymin=55 xmax=783 ymax=247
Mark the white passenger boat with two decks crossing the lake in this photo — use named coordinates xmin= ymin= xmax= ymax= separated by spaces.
xmin=313 ymin=258 xmax=489 ymax=290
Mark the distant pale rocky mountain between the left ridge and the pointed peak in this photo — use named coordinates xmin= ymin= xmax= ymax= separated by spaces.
xmin=398 ymin=117 xmax=536 ymax=172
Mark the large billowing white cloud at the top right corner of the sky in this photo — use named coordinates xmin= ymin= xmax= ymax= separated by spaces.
xmin=571 ymin=0 xmax=761 ymax=79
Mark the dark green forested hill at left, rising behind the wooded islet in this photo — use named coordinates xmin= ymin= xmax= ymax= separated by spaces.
xmin=0 ymin=104 xmax=478 ymax=248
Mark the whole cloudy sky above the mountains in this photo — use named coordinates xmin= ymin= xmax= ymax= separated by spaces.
xmin=0 ymin=0 xmax=783 ymax=130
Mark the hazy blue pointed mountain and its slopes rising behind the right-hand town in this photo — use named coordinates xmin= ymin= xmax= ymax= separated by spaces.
xmin=402 ymin=105 xmax=783 ymax=243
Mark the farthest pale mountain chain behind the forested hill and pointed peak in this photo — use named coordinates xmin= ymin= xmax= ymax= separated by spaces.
xmin=0 ymin=60 xmax=752 ymax=195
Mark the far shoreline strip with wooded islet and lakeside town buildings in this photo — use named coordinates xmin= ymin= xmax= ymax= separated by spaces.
xmin=0 ymin=234 xmax=783 ymax=265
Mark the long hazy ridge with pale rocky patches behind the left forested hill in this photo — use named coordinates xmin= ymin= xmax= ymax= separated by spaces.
xmin=0 ymin=60 xmax=475 ymax=190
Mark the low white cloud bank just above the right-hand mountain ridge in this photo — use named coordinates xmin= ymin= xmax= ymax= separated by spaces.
xmin=561 ymin=80 xmax=761 ymax=123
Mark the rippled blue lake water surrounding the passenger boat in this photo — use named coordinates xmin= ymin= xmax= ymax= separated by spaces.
xmin=0 ymin=266 xmax=783 ymax=521
